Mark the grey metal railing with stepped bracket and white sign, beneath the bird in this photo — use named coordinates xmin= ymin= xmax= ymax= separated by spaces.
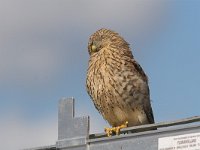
xmin=24 ymin=98 xmax=200 ymax=150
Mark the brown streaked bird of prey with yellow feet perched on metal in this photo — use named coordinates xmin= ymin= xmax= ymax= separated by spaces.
xmin=86 ymin=28 xmax=154 ymax=136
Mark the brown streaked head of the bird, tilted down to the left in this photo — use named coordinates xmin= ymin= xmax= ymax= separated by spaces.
xmin=88 ymin=28 xmax=129 ymax=55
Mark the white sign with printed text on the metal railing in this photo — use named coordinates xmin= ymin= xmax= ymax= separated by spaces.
xmin=158 ymin=133 xmax=200 ymax=150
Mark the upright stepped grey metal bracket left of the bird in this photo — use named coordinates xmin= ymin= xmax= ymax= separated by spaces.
xmin=56 ymin=98 xmax=89 ymax=148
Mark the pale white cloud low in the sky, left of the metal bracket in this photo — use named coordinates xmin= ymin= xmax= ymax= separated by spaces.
xmin=0 ymin=116 xmax=57 ymax=150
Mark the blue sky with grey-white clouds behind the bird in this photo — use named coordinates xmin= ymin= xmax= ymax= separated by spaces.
xmin=0 ymin=0 xmax=200 ymax=150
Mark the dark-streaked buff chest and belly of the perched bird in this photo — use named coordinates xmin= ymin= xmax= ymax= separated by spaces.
xmin=87 ymin=50 xmax=148 ymax=119
